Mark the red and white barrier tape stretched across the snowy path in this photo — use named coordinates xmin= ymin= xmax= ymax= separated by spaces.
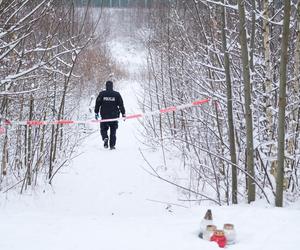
xmin=0 ymin=99 xmax=209 ymax=134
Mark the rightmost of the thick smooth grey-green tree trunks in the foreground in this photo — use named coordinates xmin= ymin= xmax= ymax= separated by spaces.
xmin=275 ymin=0 xmax=291 ymax=207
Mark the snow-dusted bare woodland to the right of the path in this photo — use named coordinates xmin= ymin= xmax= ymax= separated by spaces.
xmin=144 ymin=0 xmax=300 ymax=206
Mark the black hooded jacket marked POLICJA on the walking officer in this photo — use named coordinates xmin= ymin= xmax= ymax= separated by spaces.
xmin=95 ymin=81 xmax=125 ymax=119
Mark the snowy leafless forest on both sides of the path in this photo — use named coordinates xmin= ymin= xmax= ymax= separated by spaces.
xmin=0 ymin=0 xmax=300 ymax=207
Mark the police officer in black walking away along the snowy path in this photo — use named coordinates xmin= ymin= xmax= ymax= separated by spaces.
xmin=95 ymin=81 xmax=125 ymax=149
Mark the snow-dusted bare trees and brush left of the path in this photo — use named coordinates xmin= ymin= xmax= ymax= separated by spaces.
xmin=0 ymin=0 xmax=119 ymax=192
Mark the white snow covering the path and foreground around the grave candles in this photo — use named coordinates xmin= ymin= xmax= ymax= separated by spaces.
xmin=0 ymin=15 xmax=300 ymax=250
